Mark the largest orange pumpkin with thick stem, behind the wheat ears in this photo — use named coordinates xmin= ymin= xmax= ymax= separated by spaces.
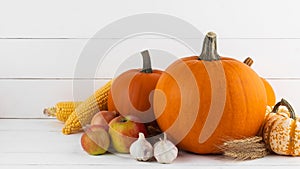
xmin=153 ymin=32 xmax=267 ymax=154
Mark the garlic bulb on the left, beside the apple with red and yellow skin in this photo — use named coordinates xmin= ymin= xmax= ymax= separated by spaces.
xmin=129 ymin=133 xmax=153 ymax=161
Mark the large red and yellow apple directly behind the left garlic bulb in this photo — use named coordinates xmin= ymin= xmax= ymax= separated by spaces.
xmin=108 ymin=116 xmax=147 ymax=153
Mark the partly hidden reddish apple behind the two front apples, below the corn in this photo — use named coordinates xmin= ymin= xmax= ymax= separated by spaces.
xmin=91 ymin=111 xmax=117 ymax=130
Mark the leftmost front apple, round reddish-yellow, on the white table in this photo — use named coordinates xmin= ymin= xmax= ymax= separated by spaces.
xmin=81 ymin=125 xmax=110 ymax=155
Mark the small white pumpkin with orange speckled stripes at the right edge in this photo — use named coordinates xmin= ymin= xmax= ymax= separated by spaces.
xmin=262 ymin=99 xmax=300 ymax=156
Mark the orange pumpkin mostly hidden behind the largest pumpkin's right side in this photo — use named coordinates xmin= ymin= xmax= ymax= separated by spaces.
xmin=244 ymin=57 xmax=276 ymax=107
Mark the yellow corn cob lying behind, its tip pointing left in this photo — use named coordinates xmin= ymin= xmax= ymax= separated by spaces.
xmin=44 ymin=101 xmax=81 ymax=122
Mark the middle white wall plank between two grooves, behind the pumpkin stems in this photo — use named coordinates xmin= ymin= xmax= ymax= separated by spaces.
xmin=0 ymin=36 xmax=300 ymax=78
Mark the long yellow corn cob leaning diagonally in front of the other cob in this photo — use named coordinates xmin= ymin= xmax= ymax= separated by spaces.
xmin=62 ymin=81 xmax=111 ymax=134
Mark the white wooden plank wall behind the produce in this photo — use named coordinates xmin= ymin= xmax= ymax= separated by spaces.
xmin=0 ymin=0 xmax=300 ymax=118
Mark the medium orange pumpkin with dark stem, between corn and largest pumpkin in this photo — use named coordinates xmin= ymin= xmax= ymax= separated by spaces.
xmin=108 ymin=50 xmax=162 ymax=123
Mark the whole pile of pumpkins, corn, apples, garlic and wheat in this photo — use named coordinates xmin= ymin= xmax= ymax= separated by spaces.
xmin=44 ymin=32 xmax=300 ymax=163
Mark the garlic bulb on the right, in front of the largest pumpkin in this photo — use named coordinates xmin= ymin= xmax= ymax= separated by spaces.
xmin=153 ymin=133 xmax=178 ymax=163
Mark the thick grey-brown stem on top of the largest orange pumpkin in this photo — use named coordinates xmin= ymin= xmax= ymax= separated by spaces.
xmin=199 ymin=32 xmax=220 ymax=61
